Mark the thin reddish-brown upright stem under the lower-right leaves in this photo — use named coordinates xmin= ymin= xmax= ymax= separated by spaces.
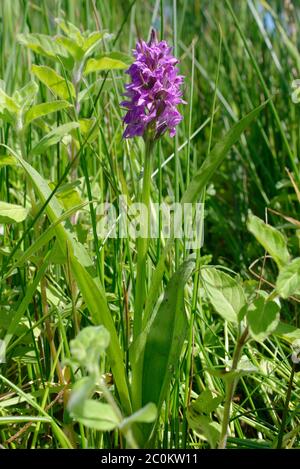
xmin=218 ymin=327 xmax=248 ymax=449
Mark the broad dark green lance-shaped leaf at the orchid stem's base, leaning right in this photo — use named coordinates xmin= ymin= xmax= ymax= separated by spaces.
xmin=138 ymin=259 xmax=195 ymax=443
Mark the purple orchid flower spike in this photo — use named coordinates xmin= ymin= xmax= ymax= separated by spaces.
xmin=121 ymin=29 xmax=184 ymax=140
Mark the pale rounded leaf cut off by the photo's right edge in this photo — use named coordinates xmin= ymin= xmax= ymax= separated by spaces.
xmin=276 ymin=257 xmax=300 ymax=298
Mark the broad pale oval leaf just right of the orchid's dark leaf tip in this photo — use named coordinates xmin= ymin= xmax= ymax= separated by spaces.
xmin=201 ymin=267 xmax=246 ymax=323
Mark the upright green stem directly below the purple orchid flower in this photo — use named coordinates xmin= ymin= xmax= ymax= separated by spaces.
xmin=133 ymin=139 xmax=154 ymax=339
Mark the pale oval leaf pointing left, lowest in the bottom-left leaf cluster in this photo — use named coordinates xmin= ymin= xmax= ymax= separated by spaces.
xmin=70 ymin=399 xmax=119 ymax=432
